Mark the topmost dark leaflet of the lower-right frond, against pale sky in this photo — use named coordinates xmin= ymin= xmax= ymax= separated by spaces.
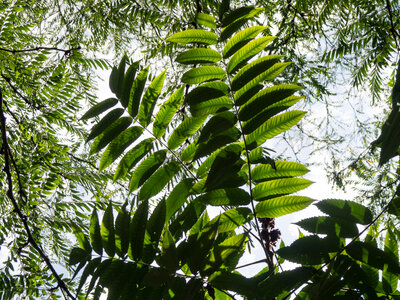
xmin=315 ymin=199 xmax=372 ymax=225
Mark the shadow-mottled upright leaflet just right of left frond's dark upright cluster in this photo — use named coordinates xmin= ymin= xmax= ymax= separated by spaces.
xmin=138 ymin=71 xmax=166 ymax=127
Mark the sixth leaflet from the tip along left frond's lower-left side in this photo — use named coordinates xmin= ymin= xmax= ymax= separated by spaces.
xmin=129 ymin=150 xmax=167 ymax=192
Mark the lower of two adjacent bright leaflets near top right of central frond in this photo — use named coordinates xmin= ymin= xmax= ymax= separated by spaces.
xmin=226 ymin=36 xmax=275 ymax=74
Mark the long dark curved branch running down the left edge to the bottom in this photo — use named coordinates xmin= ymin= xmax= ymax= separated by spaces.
xmin=0 ymin=89 xmax=75 ymax=299
